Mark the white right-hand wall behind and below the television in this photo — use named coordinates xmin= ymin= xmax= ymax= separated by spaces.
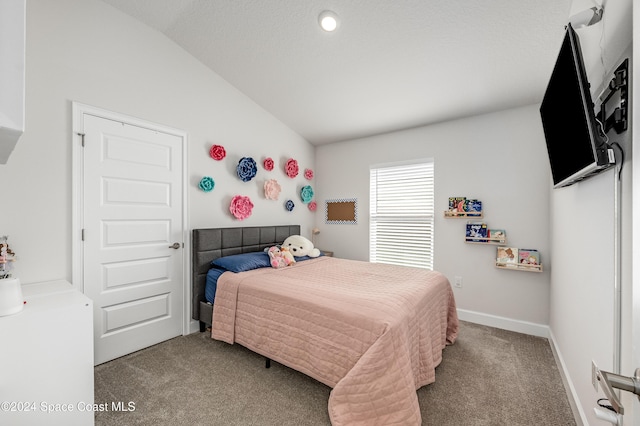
xmin=549 ymin=0 xmax=637 ymax=425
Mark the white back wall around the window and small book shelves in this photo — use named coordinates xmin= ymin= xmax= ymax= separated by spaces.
xmin=316 ymin=105 xmax=552 ymax=334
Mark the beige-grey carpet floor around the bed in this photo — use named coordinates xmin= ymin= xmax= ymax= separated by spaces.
xmin=95 ymin=322 xmax=576 ymax=426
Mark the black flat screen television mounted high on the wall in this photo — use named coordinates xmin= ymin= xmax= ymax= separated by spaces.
xmin=540 ymin=24 xmax=615 ymax=188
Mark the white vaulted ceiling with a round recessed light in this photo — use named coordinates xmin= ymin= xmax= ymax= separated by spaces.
xmin=102 ymin=0 xmax=572 ymax=144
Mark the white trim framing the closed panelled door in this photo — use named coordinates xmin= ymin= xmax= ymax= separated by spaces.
xmin=71 ymin=101 xmax=193 ymax=335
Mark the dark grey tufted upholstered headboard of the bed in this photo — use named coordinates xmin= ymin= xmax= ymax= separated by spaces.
xmin=191 ymin=225 xmax=300 ymax=323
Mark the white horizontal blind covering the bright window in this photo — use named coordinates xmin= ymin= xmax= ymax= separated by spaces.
xmin=369 ymin=160 xmax=434 ymax=270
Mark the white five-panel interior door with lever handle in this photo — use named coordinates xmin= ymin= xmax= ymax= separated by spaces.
xmin=82 ymin=114 xmax=184 ymax=365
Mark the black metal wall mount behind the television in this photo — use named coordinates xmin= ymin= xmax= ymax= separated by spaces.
xmin=598 ymin=59 xmax=629 ymax=134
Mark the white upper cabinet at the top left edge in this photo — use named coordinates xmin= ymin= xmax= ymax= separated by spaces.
xmin=0 ymin=0 xmax=26 ymax=164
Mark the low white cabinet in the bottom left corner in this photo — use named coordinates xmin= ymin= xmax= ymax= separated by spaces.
xmin=0 ymin=281 xmax=94 ymax=426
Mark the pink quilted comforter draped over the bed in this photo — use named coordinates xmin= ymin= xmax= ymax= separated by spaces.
xmin=211 ymin=257 xmax=458 ymax=426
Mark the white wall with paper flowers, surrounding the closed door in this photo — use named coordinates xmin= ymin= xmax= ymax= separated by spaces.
xmin=0 ymin=0 xmax=314 ymax=283
